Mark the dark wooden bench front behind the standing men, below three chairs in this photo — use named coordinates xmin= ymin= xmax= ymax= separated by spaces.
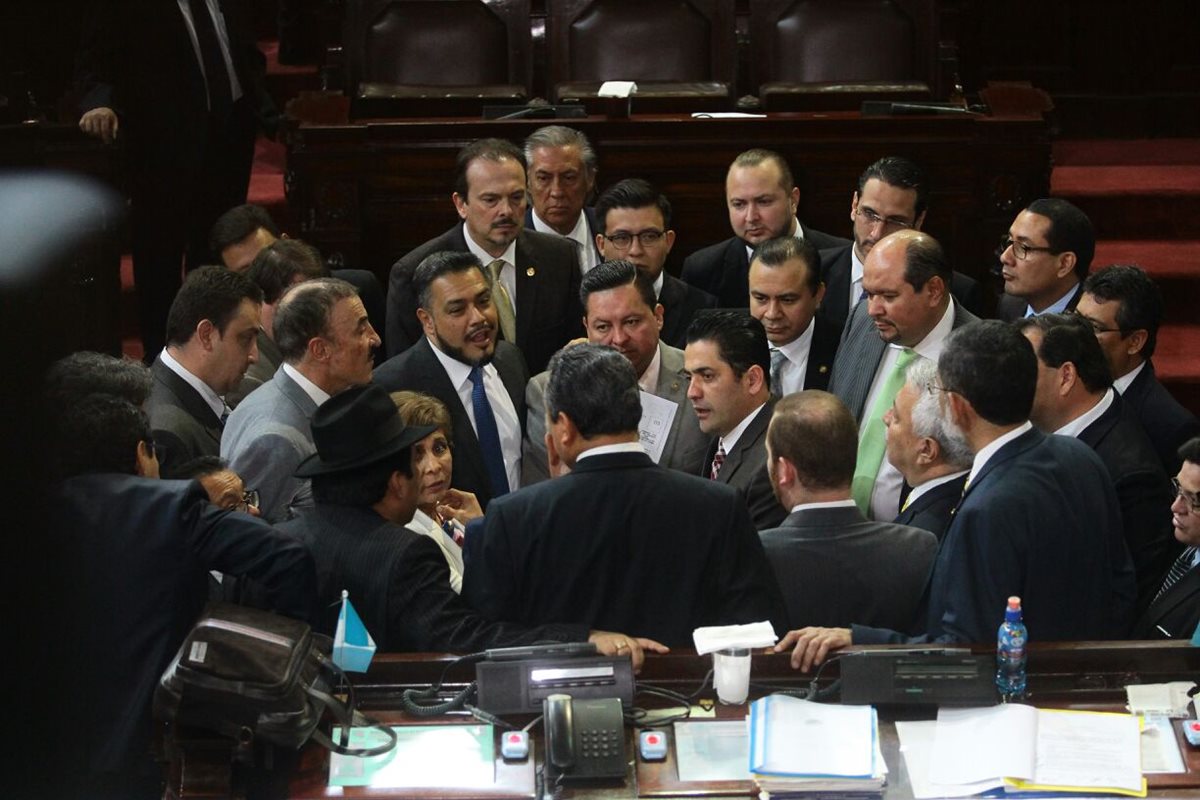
xmin=286 ymin=112 xmax=1050 ymax=291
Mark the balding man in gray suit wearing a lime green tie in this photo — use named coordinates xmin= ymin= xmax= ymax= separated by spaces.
xmin=829 ymin=230 xmax=976 ymax=521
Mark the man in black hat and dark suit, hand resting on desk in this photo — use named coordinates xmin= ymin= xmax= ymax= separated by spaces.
xmin=281 ymin=385 xmax=661 ymax=666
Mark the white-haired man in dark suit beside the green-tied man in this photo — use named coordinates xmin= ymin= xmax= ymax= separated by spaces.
xmin=883 ymin=359 xmax=974 ymax=541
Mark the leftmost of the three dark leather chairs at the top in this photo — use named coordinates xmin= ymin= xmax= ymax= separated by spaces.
xmin=342 ymin=0 xmax=532 ymax=118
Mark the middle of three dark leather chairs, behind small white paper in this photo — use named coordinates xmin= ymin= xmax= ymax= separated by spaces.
xmin=546 ymin=0 xmax=737 ymax=112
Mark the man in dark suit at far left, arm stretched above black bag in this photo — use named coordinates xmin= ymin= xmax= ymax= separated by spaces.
xmin=43 ymin=395 xmax=316 ymax=800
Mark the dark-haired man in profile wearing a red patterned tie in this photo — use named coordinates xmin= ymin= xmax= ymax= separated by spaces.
xmin=684 ymin=311 xmax=787 ymax=530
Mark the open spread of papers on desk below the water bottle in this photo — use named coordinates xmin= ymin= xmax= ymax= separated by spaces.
xmin=896 ymin=704 xmax=1146 ymax=800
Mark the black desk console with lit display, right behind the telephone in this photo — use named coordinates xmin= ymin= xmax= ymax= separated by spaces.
xmin=475 ymin=656 xmax=634 ymax=714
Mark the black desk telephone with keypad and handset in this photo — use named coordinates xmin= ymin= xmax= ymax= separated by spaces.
xmin=541 ymin=694 xmax=626 ymax=781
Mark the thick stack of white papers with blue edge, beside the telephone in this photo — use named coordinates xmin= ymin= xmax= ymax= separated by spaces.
xmin=749 ymin=694 xmax=887 ymax=798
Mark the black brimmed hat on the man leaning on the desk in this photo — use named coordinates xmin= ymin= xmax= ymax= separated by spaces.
xmin=295 ymin=384 xmax=437 ymax=477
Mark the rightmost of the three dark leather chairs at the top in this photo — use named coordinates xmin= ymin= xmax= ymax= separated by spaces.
xmin=750 ymin=0 xmax=936 ymax=110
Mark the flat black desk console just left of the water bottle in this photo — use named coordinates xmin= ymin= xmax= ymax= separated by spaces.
xmin=839 ymin=648 xmax=997 ymax=705
